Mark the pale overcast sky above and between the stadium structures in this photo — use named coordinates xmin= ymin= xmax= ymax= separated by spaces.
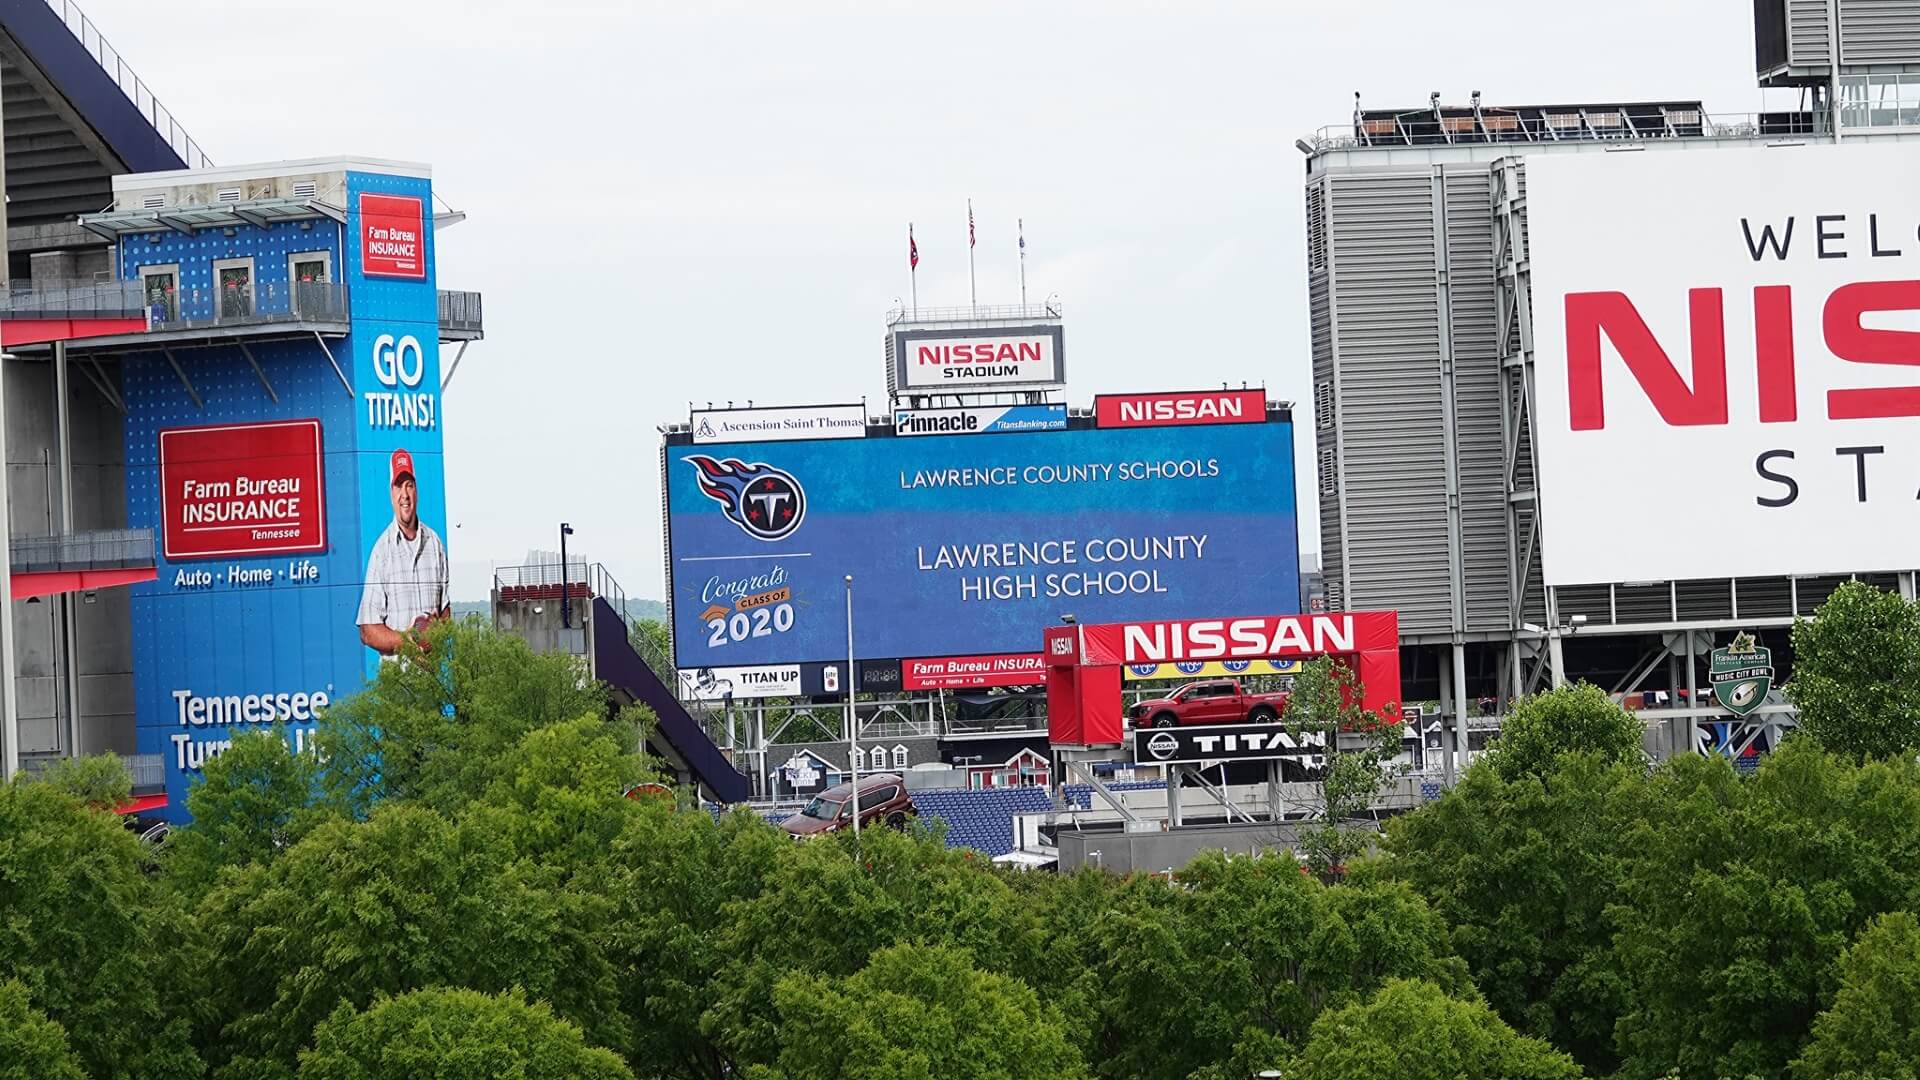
xmin=81 ymin=0 xmax=1763 ymax=600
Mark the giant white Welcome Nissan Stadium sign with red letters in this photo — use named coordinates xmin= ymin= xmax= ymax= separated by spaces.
xmin=1526 ymin=144 xmax=1920 ymax=584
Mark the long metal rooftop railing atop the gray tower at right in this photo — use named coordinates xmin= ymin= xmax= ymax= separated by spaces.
xmin=1302 ymin=110 xmax=1828 ymax=154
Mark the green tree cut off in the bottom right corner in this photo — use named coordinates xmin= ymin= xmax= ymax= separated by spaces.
xmin=1793 ymin=911 xmax=1920 ymax=1080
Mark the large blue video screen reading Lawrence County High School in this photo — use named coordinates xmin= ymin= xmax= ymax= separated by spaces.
xmin=666 ymin=419 xmax=1300 ymax=668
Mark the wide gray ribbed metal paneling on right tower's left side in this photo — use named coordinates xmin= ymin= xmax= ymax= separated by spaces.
xmin=1315 ymin=169 xmax=1452 ymax=632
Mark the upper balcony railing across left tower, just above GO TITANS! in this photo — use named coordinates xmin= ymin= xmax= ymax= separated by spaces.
xmin=0 ymin=281 xmax=482 ymax=338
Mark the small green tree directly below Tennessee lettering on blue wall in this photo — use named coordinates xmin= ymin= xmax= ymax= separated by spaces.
xmin=165 ymin=726 xmax=326 ymax=897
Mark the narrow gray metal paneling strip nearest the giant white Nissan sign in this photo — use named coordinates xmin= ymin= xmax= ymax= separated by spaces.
xmin=1444 ymin=165 xmax=1513 ymax=632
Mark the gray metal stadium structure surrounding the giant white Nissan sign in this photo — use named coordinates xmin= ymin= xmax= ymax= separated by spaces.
xmin=1298 ymin=0 xmax=1920 ymax=749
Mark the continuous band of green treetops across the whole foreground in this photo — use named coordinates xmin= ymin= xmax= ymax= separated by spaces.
xmin=11 ymin=607 xmax=1920 ymax=1080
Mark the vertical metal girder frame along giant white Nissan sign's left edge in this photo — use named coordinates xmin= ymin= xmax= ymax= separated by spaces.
xmin=1492 ymin=158 xmax=1553 ymax=694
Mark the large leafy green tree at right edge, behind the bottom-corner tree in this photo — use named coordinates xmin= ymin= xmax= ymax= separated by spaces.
xmin=1609 ymin=740 xmax=1920 ymax=1078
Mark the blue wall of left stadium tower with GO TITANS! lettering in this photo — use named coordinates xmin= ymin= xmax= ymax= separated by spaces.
xmin=117 ymin=171 xmax=447 ymax=821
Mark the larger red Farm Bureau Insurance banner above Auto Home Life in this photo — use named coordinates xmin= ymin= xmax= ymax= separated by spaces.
xmin=159 ymin=421 xmax=326 ymax=559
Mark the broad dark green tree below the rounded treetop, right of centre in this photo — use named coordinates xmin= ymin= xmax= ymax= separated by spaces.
xmin=1382 ymin=753 xmax=1649 ymax=1074
